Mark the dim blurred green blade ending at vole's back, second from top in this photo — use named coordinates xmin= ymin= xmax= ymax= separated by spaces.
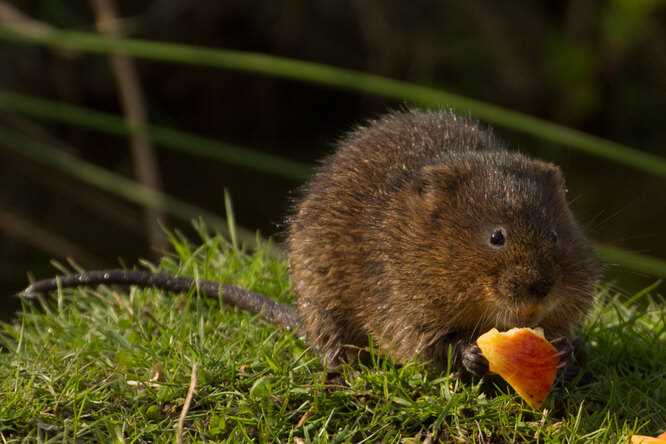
xmin=0 ymin=92 xmax=310 ymax=180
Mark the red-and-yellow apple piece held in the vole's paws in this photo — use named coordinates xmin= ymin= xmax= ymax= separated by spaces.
xmin=476 ymin=328 xmax=559 ymax=409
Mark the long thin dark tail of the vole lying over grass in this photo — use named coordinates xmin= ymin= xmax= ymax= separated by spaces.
xmin=19 ymin=270 xmax=299 ymax=330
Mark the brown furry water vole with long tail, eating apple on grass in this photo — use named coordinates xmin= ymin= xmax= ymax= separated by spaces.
xmin=24 ymin=110 xmax=599 ymax=374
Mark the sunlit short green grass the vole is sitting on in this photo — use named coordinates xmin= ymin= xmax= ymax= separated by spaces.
xmin=0 ymin=229 xmax=666 ymax=443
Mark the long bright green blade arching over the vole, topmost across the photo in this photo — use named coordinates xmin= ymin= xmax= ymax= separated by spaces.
xmin=0 ymin=25 xmax=666 ymax=177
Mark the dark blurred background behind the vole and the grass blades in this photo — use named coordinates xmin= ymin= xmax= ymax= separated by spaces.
xmin=0 ymin=0 xmax=666 ymax=320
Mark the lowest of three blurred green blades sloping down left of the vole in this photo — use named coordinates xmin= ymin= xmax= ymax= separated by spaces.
xmin=0 ymin=128 xmax=256 ymax=245
